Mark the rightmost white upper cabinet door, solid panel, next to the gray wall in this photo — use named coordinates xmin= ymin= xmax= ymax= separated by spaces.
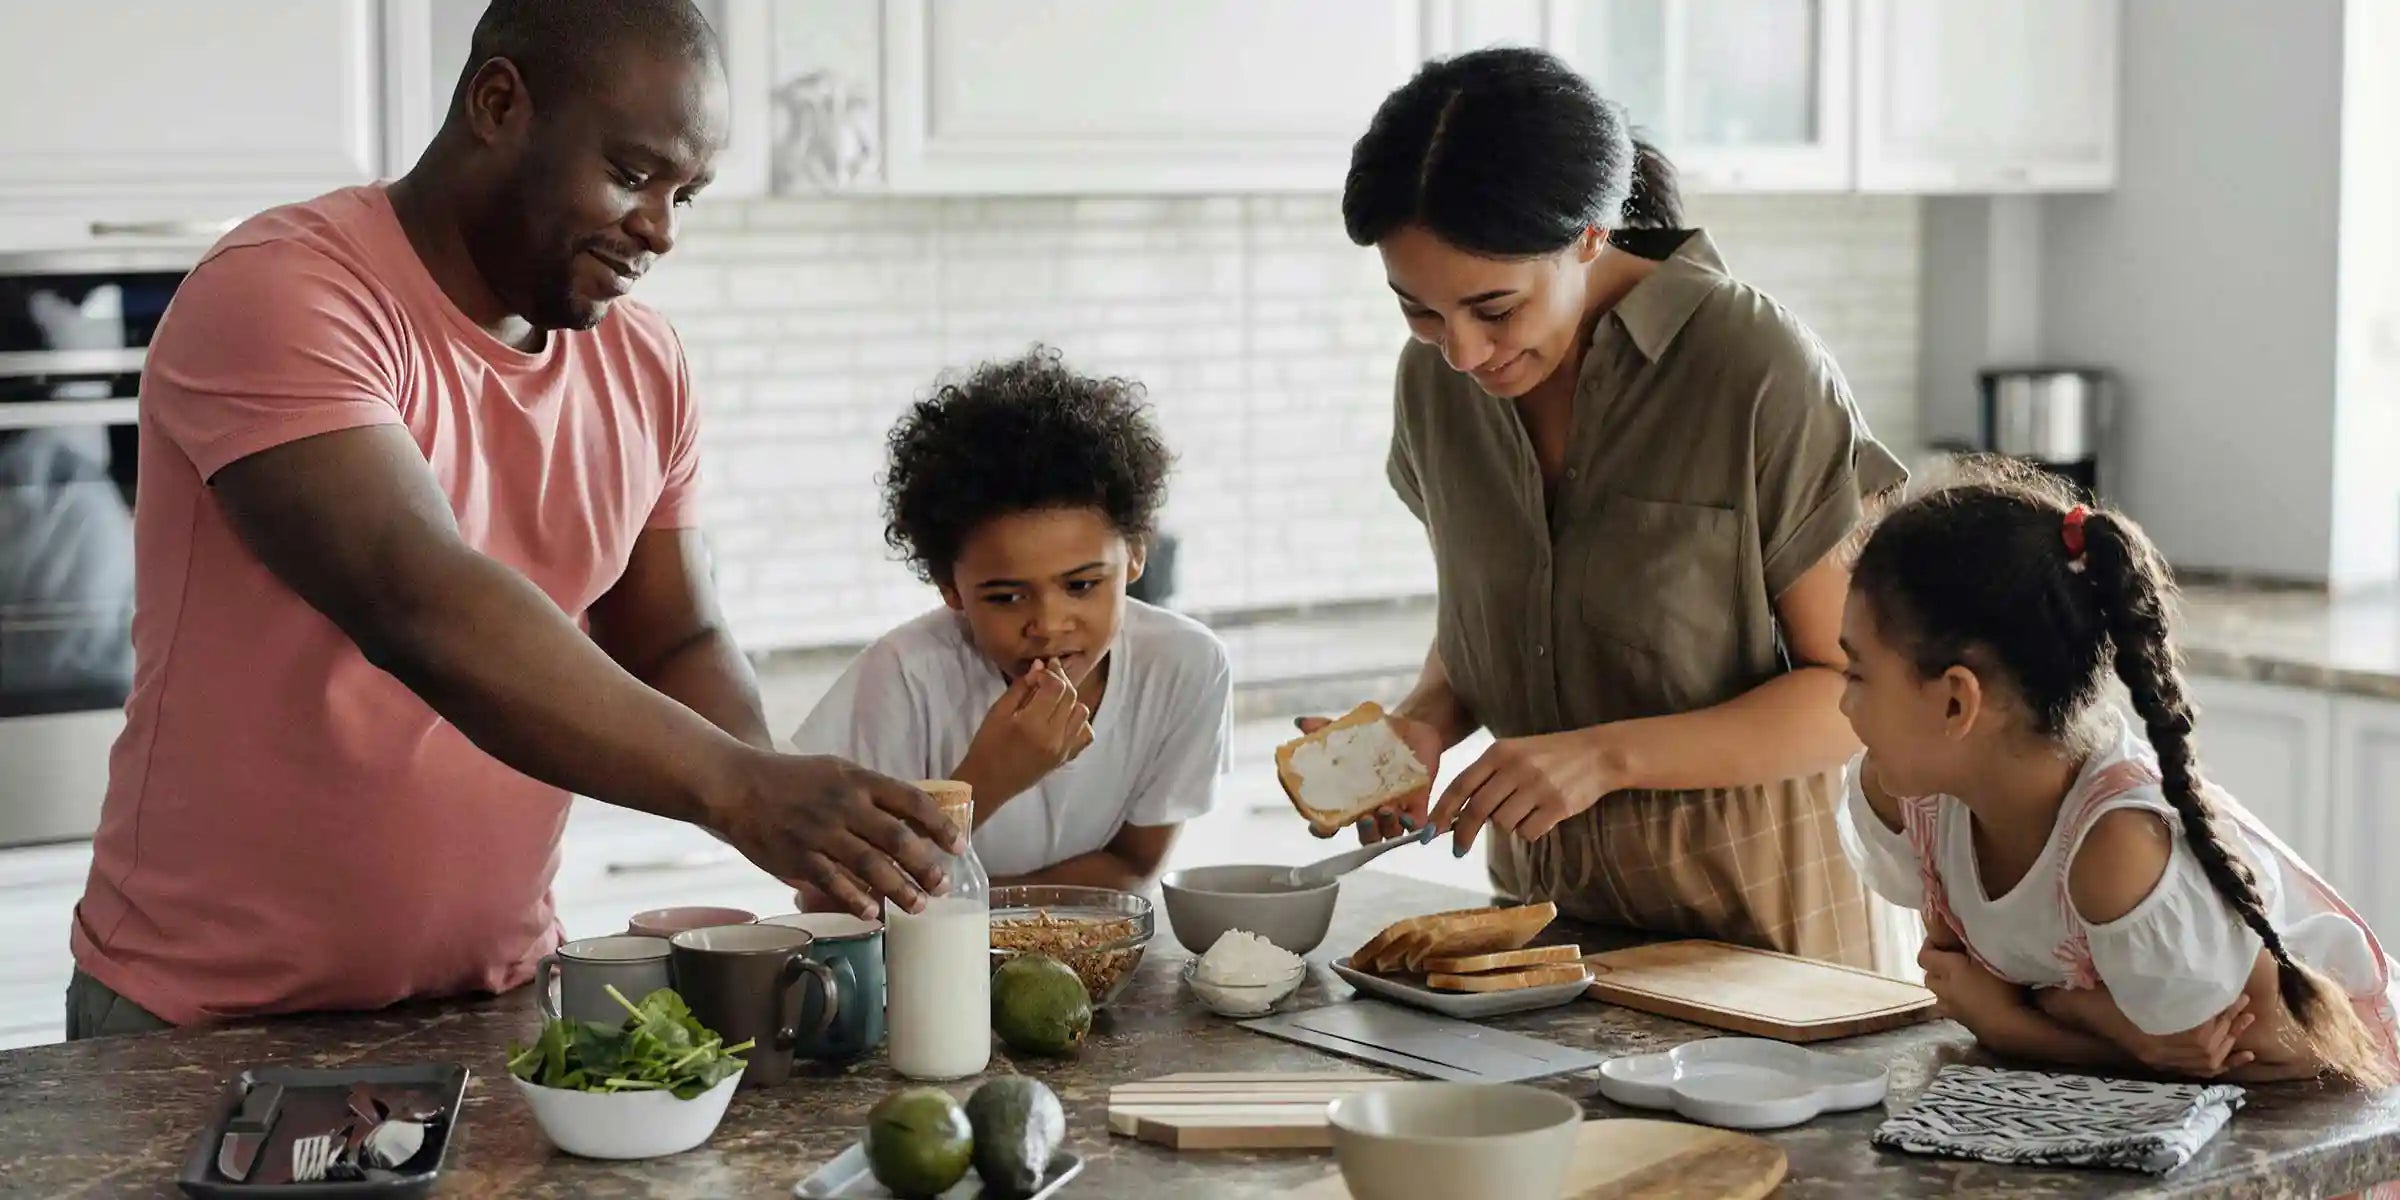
xmin=1858 ymin=0 xmax=2119 ymax=192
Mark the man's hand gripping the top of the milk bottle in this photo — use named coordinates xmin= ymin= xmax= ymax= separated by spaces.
xmin=710 ymin=751 xmax=965 ymax=919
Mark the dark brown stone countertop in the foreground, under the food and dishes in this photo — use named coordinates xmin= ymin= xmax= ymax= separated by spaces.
xmin=0 ymin=874 xmax=2400 ymax=1200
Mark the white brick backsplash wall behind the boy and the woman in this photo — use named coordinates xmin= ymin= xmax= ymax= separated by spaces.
xmin=638 ymin=194 xmax=1920 ymax=650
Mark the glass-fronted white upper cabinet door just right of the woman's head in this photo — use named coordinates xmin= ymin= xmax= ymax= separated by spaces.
xmin=1541 ymin=0 xmax=1855 ymax=192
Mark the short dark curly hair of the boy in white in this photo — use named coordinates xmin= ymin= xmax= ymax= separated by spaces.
xmin=883 ymin=346 xmax=1174 ymax=583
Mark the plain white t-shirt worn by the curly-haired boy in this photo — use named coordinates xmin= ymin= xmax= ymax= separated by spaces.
xmin=792 ymin=598 xmax=1234 ymax=876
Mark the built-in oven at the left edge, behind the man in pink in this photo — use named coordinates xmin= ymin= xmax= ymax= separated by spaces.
xmin=0 ymin=247 xmax=199 ymax=845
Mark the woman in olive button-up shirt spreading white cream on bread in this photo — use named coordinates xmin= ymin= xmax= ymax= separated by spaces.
xmin=1342 ymin=48 xmax=1906 ymax=965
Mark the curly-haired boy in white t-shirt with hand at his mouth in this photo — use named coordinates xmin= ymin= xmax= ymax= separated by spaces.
xmin=792 ymin=350 xmax=1231 ymax=892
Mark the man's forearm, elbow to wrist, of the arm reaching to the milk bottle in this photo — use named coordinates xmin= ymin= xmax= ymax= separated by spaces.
xmin=352 ymin=552 xmax=746 ymax=823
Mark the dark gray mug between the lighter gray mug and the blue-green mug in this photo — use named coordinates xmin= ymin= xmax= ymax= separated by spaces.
xmin=672 ymin=924 xmax=842 ymax=1087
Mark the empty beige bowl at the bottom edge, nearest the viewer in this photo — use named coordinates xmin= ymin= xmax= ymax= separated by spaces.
xmin=1330 ymin=1082 xmax=1584 ymax=1200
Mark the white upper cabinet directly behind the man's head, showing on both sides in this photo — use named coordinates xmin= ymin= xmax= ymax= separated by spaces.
xmin=382 ymin=0 xmax=772 ymax=199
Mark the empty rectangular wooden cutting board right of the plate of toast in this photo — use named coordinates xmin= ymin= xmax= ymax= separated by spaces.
xmin=1584 ymin=941 xmax=1934 ymax=1042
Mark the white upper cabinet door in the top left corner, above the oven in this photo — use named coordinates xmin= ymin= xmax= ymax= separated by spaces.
xmin=0 ymin=0 xmax=382 ymax=221
